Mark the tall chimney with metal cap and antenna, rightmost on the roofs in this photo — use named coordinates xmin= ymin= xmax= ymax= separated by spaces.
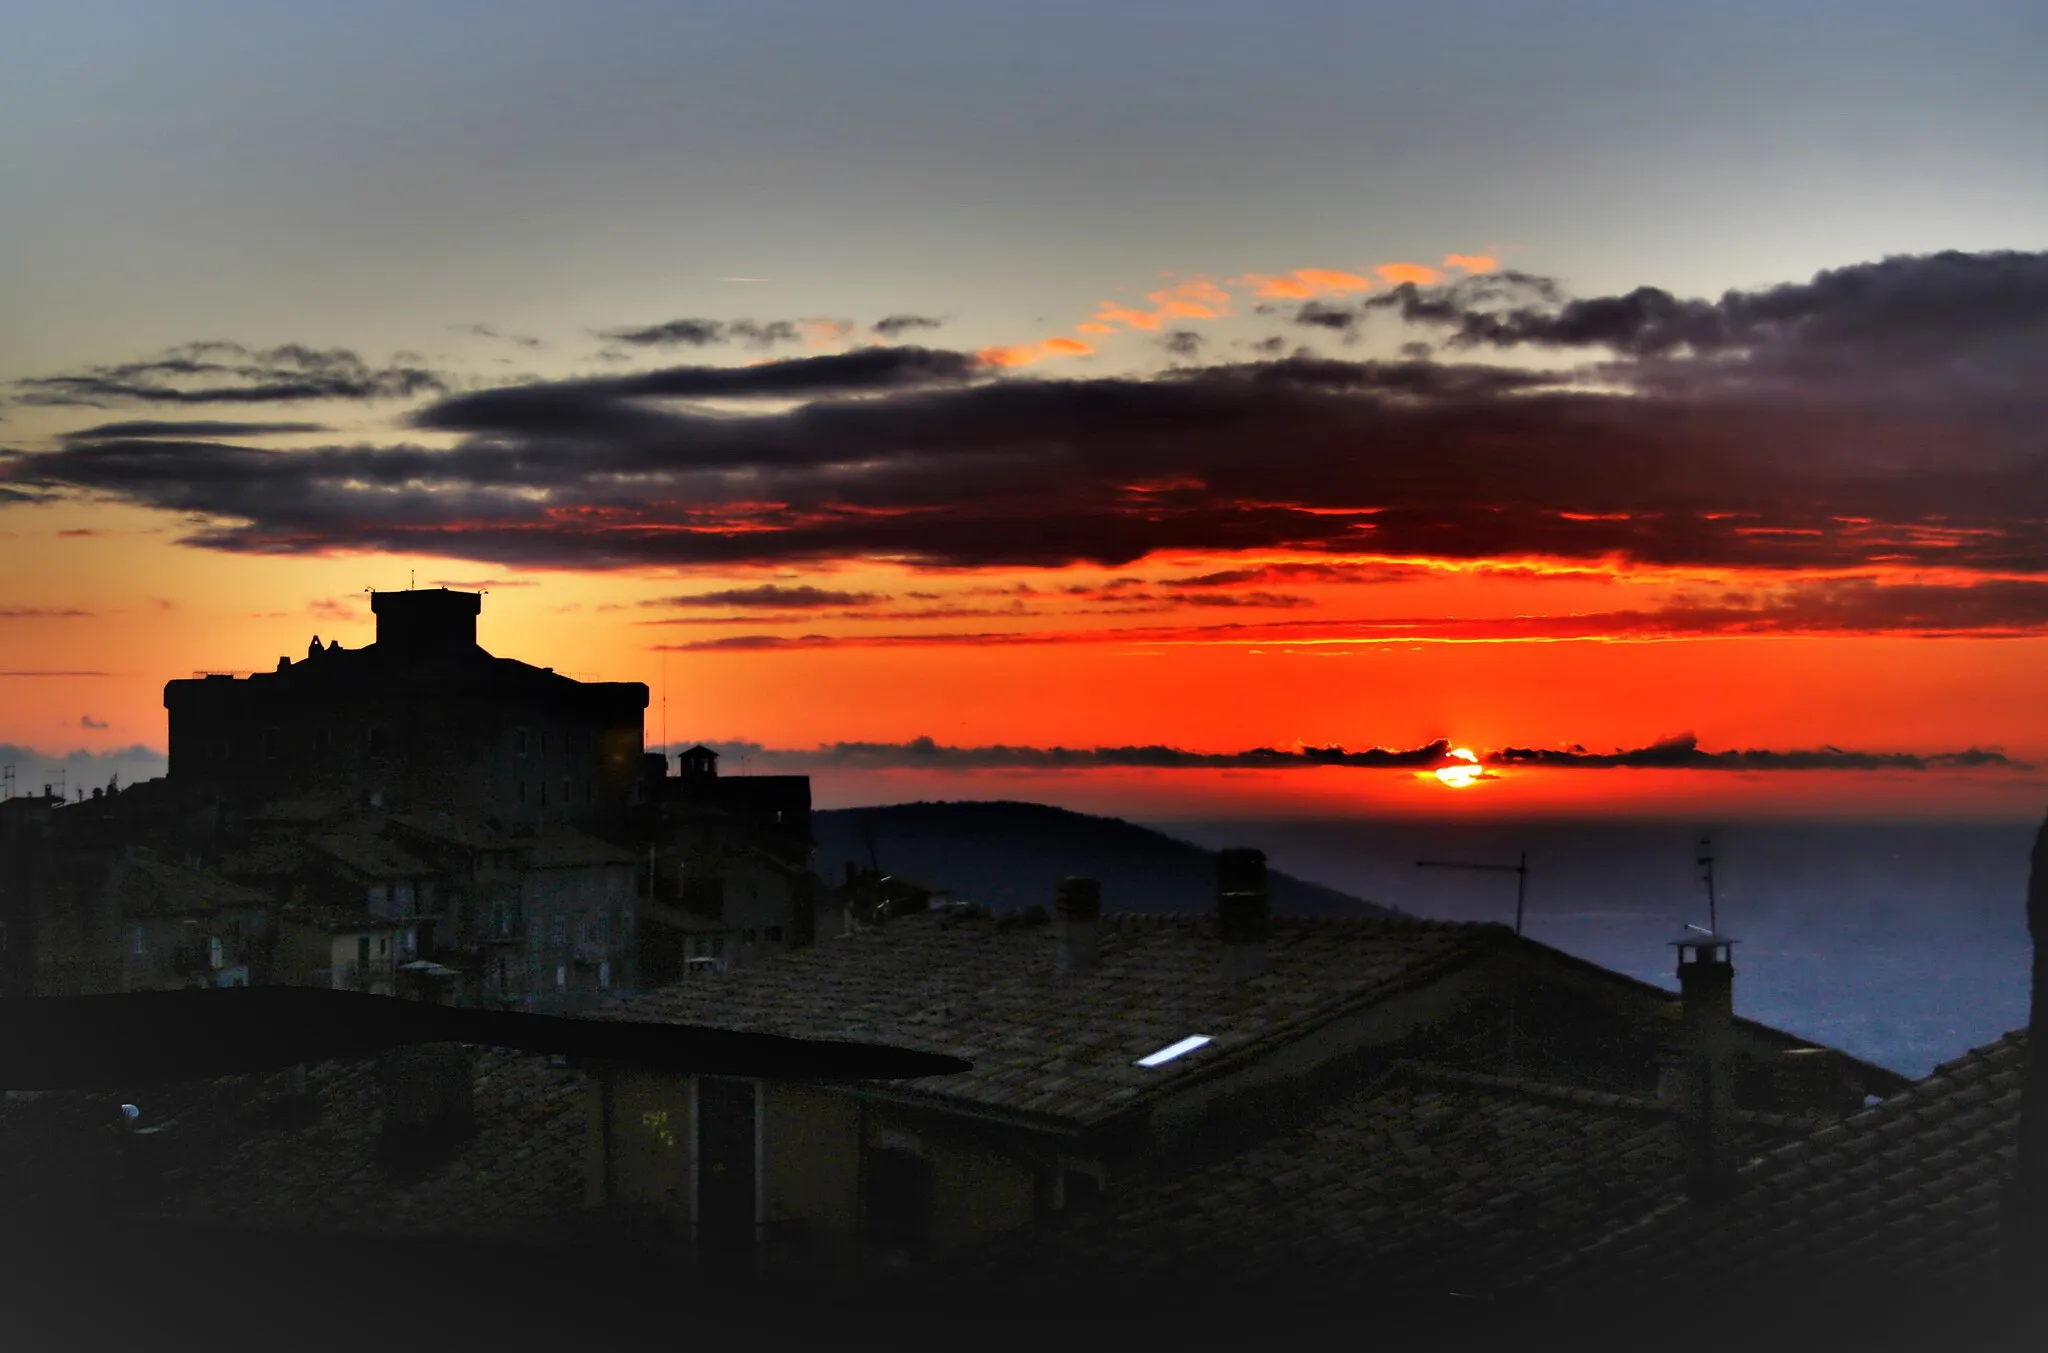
xmin=1671 ymin=929 xmax=1735 ymax=1204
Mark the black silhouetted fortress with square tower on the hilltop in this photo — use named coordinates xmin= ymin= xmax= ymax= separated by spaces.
xmin=164 ymin=590 xmax=647 ymax=825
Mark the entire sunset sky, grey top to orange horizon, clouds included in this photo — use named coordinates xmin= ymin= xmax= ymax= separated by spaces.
xmin=0 ymin=0 xmax=2048 ymax=817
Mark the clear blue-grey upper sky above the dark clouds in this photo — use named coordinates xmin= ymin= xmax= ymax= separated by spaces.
xmin=0 ymin=0 xmax=2048 ymax=379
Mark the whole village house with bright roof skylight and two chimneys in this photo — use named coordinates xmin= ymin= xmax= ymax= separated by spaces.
xmin=590 ymin=852 xmax=1905 ymax=1283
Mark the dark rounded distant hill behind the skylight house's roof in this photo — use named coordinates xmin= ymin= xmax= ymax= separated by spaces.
xmin=811 ymin=802 xmax=1395 ymax=917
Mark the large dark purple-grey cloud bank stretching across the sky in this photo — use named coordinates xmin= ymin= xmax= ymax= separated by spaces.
xmin=0 ymin=254 xmax=2048 ymax=626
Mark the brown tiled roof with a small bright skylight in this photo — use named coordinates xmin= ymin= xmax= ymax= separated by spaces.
xmin=596 ymin=913 xmax=1507 ymax=1128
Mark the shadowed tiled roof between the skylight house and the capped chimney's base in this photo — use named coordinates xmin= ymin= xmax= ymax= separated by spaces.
xmin=920 ymin=1062 xmax=1810 ymax=1302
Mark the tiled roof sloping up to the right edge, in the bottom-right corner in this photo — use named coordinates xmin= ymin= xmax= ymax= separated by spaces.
xmin=1524 ymin=1030 xmax=2028 ymax=1290
